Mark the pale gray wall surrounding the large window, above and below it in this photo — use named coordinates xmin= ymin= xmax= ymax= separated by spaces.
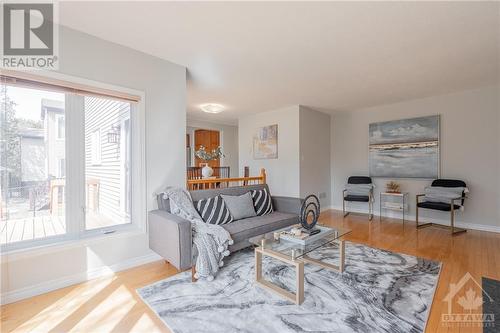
xmin=1 ymin=27 xmax=186 ymax=302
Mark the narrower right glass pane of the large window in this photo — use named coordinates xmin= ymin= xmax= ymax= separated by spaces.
xmin=84 ymin=97 xmax=130 ymax=229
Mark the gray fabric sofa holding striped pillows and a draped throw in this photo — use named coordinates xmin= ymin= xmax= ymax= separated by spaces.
xmin=149 ymin=184 xmax=302 ymax=270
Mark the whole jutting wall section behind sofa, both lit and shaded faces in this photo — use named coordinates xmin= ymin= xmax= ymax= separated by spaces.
xmin=239 ymin=105 xmax=331 ymax=202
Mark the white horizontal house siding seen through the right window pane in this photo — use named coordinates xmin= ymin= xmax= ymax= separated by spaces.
xmin=85 ymin=97 xmax=130 ymax=220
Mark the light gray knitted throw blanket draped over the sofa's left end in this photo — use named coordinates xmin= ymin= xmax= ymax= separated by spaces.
xmin=163 ymin=187 xmax=233 ymax=281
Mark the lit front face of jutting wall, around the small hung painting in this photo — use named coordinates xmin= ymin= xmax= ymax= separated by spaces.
xmin=238 ymin=105 xmax=300 ymax=197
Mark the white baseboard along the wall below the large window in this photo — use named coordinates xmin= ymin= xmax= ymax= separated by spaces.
xmin=0 ymin=253 xmax=161 ymax=305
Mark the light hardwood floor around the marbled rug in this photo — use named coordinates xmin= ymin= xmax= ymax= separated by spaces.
xmin=0 ymin=211 xmax=500 ymax=333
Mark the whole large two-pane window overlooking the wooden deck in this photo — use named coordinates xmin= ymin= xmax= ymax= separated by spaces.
xmin=0 ymin=72 xmax=144 ymax=249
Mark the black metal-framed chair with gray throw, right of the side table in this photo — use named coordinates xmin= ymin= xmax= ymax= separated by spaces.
xmin=415 ymin=179 xmax=467 ymax=235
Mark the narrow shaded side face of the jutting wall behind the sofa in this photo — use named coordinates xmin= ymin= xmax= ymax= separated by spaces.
xmin=299 ymin=106 xmax=331 ymax=209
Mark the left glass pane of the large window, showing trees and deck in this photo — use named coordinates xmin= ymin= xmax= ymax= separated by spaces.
xmin=0 ymin=85 xmax=66 ymax=244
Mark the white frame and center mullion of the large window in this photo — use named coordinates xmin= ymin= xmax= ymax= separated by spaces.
xmin=0 ymin=70 xmax=147 ymax=252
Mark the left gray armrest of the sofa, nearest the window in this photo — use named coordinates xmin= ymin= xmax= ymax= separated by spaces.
xmin=148 ymin=210 xmax=193 ymax=270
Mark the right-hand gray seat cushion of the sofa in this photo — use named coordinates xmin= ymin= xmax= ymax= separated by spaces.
xmin=223 ymin=212 xmax=299 ymax=244
